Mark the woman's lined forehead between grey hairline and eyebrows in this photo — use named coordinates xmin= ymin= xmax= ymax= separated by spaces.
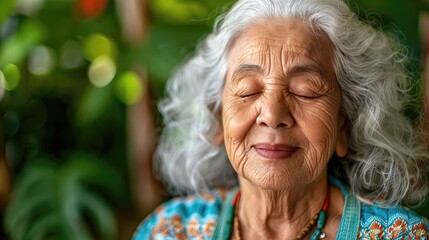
xmin=228 ymin=19 xmax=333 ymax=67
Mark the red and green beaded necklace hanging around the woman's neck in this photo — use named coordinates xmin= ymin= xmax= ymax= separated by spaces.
xmin=231 ymin=190 xmax=329 ymax=240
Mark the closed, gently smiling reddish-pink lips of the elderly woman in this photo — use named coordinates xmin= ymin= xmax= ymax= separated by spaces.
xmin=253 ymin=143 xmax=298 ymax=159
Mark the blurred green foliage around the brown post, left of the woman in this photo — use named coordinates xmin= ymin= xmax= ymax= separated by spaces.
xmin=0 ymin=0 xmax=232 ymax=239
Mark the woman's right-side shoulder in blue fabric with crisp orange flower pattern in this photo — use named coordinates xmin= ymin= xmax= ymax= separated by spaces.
xmin=359 ymin=204 xmax=429 ymax=239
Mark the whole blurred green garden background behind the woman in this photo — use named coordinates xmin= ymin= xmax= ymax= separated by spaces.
xmin=0 ymin=0 xmax=429 ymax=239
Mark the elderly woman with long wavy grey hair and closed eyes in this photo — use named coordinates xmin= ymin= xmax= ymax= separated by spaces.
xmin=134 ymin=0 xmax=429 ymax=239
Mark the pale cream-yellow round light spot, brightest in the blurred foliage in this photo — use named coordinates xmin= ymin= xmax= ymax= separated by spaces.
xmin=88 ymin=56 xmax=116 ymax=87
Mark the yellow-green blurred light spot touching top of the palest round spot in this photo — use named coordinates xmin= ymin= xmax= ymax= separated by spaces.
xmin=83 ymin=33 xmax=118 ymax=62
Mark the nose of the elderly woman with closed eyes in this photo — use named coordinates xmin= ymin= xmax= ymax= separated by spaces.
xmin=256 ymin=93 xmax=294 ymax=129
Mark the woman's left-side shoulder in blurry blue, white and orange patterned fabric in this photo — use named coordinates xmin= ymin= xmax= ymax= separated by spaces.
xmin=133 ymin=189 xmax=230 ymax=240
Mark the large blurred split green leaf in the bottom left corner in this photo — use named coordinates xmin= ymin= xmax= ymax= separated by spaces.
xmin=4 ymin=154 xmax=123 ymax=240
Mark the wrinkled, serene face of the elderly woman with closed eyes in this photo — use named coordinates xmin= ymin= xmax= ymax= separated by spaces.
xmin=222 ymin=20 xmax=347 ymax=189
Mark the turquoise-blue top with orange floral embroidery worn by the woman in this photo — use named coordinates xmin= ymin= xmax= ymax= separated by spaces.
xmin=133 ymin=178 xmax=429 ymax=240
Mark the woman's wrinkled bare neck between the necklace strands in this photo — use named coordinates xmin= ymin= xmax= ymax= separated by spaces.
xmin=238 ymin=174 xmax=329 ymax=239
